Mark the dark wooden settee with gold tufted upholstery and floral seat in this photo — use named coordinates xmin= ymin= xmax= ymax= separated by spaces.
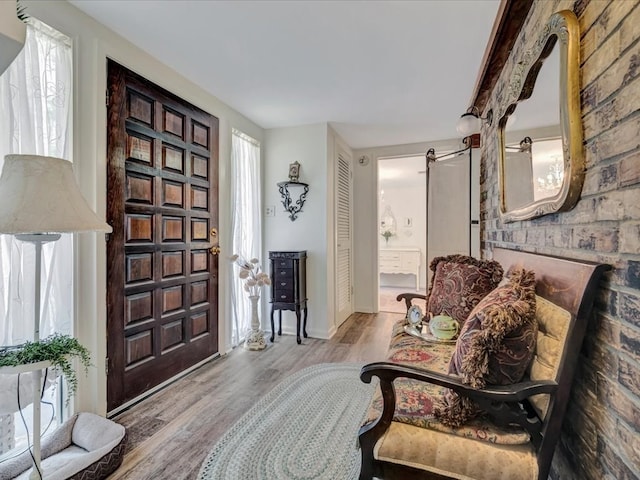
xmin=359 ymin=248 xmax=608 ymax=480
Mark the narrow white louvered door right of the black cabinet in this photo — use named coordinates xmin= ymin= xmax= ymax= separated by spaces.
xmin=335 ymin=149 xmax=353 ymax=328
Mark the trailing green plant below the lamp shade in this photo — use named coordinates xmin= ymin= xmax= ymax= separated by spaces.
xmin=0 ymin=333 xmax=91 ymax=395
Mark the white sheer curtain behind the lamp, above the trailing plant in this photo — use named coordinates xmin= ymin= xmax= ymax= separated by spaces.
xmin=0 ymin=19 xmax=73 ymax=345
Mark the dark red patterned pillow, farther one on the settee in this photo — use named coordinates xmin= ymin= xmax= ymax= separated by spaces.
xmin=427 ymin=255 xmax=504 ymax=326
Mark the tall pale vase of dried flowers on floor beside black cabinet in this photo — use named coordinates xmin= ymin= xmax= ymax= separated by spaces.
xmin=230 ymin=254 xmax=271 ymax=350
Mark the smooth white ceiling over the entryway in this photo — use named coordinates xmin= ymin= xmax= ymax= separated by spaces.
xmin=70 ymin=0 xmax=499 ymax=148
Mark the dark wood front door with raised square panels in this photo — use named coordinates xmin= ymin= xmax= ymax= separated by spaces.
xmin=107 ymin=61 xmax=218 ymax=411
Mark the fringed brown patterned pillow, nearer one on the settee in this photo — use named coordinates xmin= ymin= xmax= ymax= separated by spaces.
xmin=435 ymin=269 xmax=538 ymax=426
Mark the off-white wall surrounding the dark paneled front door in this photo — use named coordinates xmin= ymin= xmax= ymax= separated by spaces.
xmin=24 ymin=0 xmax=262 ymax=414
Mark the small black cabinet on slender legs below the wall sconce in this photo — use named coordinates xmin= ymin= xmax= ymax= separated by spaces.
xmin=269 ymin=250 xmax=307 ymax=343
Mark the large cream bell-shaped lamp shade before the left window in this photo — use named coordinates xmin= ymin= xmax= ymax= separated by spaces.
xmin=0 ymin=155 xmax=112 ymax=234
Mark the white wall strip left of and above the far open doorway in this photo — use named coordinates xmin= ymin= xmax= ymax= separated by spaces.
xmin=353 ymin=139 xmax=463 ymax=312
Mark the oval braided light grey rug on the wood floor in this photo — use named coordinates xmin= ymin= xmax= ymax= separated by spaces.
xmin=198 ymin=363 xmax=375 ymax=480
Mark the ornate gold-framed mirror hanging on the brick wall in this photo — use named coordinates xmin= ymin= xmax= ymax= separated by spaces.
xmin=497 ymin=10 xmax=584 ymax=222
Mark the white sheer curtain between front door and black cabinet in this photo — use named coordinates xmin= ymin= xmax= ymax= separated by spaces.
xmin=231 ymin=129 xmax=265 ymax=346
